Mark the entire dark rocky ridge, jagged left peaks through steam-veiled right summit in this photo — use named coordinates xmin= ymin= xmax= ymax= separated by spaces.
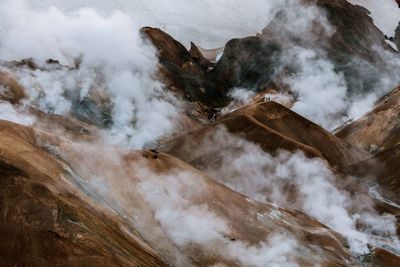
xmin=142 ymin=0 xmax=391 ymax=111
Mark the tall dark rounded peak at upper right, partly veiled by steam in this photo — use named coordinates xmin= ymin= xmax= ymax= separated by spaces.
xmin=260 ymin=0 xmax=390 ymax=95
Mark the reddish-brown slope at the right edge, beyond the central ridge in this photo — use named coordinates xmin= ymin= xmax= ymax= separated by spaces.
xmin=336 ymin=87 xmax=400 ymax=203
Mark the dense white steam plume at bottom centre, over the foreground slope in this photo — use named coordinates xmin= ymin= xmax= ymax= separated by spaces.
xmin=139 ymin=170 xmax=299 ymax=267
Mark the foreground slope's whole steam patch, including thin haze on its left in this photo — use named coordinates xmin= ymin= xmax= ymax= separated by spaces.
xmin=60 ymin=147 xmax=306 ymax=267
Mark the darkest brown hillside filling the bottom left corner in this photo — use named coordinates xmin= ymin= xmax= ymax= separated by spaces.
xmin=0 ymin=163 xmax=165 ymax=266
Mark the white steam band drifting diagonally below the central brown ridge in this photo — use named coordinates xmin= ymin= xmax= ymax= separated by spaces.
xmin=191 ymin=128 xmax=397 ymax=254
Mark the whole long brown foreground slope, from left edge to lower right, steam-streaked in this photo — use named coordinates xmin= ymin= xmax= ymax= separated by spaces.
xmin=0 ymin=121 xmax=352 ymax=266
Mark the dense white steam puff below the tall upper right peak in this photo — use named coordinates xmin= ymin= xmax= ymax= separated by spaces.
xmin=287 ymin=47 xmax=347 ymax=129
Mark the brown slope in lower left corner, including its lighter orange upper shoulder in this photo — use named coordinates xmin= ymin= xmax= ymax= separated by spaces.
xmin=0 ymin=121 xmax=165 ymax=266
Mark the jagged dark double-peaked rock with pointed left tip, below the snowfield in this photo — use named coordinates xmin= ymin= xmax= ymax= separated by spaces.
xmin=142 ymin=27 xmax=279 ymax=108
